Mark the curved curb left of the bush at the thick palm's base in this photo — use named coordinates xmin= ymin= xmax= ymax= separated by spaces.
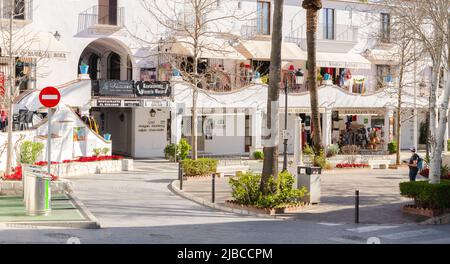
xmin=168 ymin=180 xmax=282 ymax=219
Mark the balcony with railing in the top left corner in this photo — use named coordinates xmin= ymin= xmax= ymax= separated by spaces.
xmin=0 ymin=0 xmax=33 ymax=23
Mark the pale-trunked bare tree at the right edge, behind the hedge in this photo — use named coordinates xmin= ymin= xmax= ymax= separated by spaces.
xmin=389 ymin=0 xmax=450 ymax=183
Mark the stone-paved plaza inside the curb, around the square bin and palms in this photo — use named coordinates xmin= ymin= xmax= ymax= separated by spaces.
xmin=178 ymin=168 xmax=426 ymax=224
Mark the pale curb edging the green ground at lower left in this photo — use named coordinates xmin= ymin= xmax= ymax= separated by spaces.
xmin=2 ymin=193 xmax=101 ymax=229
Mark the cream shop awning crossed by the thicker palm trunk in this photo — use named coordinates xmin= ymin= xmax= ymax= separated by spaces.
xmin=239 ymin=40 xmax=307 ymax=61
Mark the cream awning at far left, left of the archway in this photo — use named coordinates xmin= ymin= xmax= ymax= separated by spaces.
xmin=0 ymin=30 xmax=68 ymax=59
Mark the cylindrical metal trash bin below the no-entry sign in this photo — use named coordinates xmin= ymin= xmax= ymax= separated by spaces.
xmin=23 ymin=167 xmax=52 ymax=216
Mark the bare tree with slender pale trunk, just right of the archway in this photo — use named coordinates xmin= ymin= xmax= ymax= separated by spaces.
xmin=141 ymin=0 xmax=250 ymax=159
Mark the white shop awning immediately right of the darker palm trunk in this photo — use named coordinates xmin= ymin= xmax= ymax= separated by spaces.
xmin=317 ymin=52 xmax=371 ymax=70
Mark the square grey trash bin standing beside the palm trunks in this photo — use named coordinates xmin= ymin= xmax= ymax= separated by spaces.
xmin=297 ymin=166 xmax=322 ymax=204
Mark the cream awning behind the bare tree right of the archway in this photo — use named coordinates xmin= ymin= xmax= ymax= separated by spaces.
xmin=166 ymin=37 xmax=246 ymax=60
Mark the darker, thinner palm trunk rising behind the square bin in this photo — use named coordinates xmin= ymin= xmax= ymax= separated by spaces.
xmin=306 ymin=8 xmax=322 ymax=156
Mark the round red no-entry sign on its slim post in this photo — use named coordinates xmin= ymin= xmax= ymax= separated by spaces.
xmin=39 ymin=87 xmax=61 ymax=176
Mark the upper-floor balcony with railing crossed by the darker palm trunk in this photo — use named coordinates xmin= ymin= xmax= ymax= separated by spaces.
xmin=284 ymin=23 xmax=359 ymax=52
